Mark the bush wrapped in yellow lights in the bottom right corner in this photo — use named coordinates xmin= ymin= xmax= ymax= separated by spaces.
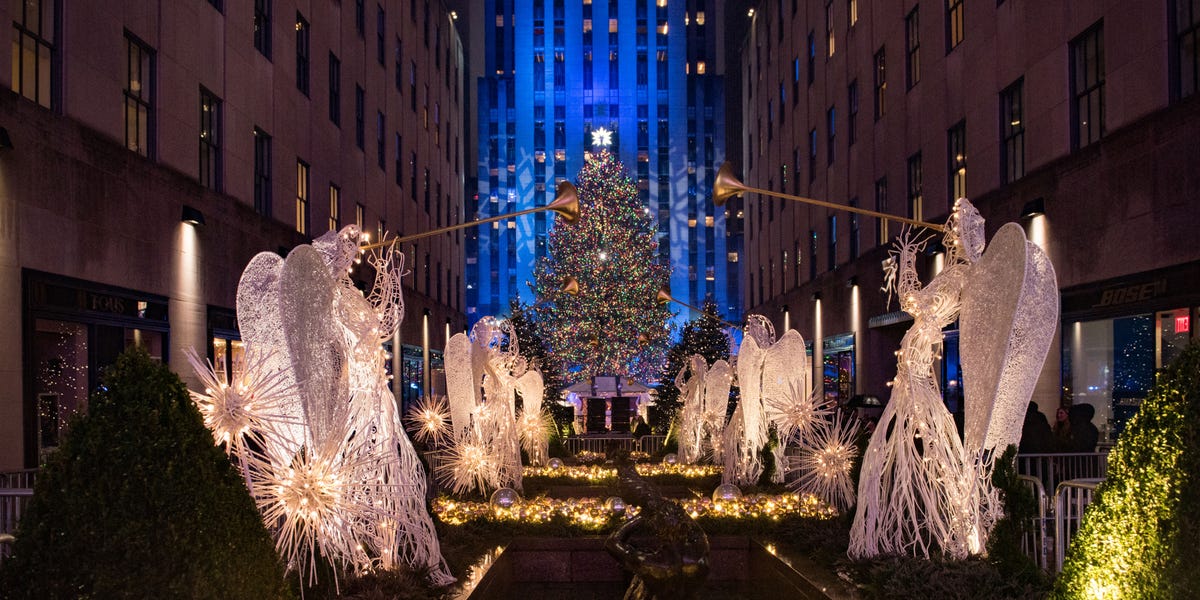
xmin=1055 ymin=343 xmax=1200 ymax=599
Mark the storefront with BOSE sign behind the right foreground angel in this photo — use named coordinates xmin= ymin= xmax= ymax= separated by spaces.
xmin=1062 ymin=262 xmax=1200 ymax=443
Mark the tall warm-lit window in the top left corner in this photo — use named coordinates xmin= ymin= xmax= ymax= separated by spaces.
xmin=12 ymin=0 xmax=60 ymax=108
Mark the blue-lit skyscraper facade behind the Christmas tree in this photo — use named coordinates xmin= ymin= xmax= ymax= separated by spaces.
xmin=467 ymin=0 xmax=740 ymax=322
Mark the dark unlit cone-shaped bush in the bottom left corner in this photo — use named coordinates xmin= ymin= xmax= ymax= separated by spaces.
xmin=0 ymin=349 xmax=288 ymax=599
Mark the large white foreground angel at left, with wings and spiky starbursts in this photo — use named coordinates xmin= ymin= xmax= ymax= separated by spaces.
xmin=190 ymin=226 xmax=454 ymax=586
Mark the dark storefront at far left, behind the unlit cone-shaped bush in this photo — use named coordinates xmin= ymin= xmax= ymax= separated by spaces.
xmin=22 ymin=270 xmax=169 ymax=467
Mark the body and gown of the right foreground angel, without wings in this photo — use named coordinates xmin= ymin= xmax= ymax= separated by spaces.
xmin=850 ymin=199 xmax=990 ymax=558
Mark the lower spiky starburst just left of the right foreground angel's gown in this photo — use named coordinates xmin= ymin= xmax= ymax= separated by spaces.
xmin=791 ymin=414 xmax=858 ymax=510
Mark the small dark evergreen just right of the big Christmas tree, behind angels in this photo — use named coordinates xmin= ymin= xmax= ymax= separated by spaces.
xmin=650 ymin=300 xmax=730 ymax=431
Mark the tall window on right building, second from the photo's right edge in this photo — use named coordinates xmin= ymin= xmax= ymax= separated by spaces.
xmin=1070 ymin=23 xmax=1104 ymax=149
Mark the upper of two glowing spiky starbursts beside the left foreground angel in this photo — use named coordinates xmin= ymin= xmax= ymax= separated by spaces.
xmin=184 ymin=346 xmax=301 ymax=455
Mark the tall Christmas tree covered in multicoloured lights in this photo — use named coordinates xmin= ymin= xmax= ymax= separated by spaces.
xmin=533 ymin=150 xmax=672 ymax=383
